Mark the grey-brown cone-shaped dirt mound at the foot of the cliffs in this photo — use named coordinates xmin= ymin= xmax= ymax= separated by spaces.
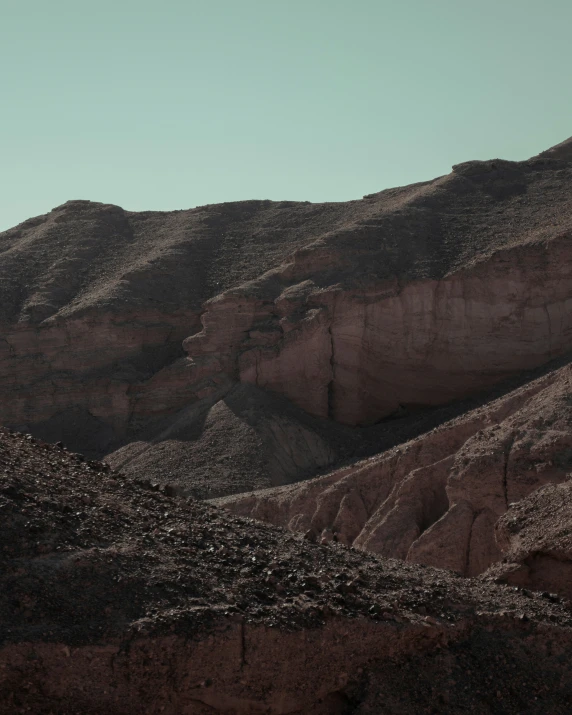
xmin=106 ymin=385 xmax=363 ymax=498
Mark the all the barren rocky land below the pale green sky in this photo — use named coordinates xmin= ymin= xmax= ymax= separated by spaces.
xmin=0 ymin=140 xmax=572 ymax=715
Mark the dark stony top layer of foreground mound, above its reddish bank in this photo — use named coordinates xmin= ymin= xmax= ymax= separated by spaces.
xmin=0 ymin=430 xmax=572 ymax=643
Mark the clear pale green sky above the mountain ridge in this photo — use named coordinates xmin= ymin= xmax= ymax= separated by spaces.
xmin=0 ymin=0 xmax=572 ymax=230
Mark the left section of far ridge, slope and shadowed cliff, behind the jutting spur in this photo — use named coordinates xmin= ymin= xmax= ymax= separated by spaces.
xmin=0 ymin=196 xmax=343 ymax=455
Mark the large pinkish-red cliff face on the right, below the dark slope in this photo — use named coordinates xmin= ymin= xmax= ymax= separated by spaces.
xmin=183 ymin=234 xmax=572 ymax=425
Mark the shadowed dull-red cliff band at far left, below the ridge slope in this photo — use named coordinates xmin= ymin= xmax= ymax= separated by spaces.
xmin=0 ymin=310 xmax=199 ymax=454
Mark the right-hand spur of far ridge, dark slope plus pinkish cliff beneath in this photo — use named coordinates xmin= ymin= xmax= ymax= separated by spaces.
xmin=183 ymin=155 xmax=572 ymax=424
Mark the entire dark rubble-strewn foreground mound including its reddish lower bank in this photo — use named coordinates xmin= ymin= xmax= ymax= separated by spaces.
xmin=0 ymin=430 xmax=572 ymax=715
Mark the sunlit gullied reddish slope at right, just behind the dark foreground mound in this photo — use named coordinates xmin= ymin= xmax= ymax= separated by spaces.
xmin=217 ymin=365 xmax=572 ymax=576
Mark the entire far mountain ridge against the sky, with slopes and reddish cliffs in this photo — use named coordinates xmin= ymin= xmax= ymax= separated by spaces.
xmin=0 ymin=138 xmax=572 ymax=504
